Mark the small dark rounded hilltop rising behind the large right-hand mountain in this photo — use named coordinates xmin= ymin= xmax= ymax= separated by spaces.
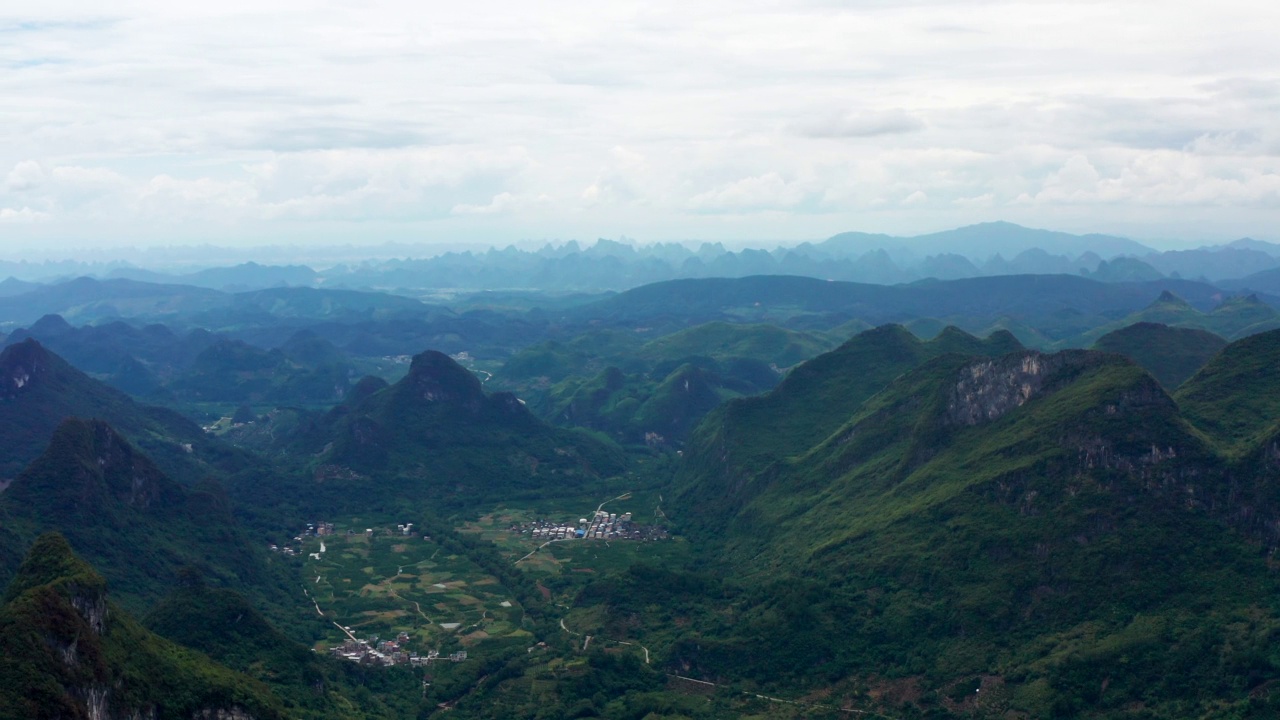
xmin=1093 ymin=323 xmax=1226 ymax=389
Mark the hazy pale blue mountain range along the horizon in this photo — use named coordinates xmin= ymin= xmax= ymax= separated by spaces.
xmin=0 ymin=223 xmax=1280 ymax=292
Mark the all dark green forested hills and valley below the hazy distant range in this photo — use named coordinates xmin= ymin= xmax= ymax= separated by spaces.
xmin=0 ymin=265 xmax=1280 ymax=720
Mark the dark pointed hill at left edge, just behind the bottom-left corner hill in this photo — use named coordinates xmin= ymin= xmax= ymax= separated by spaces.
xmin=0 ymin=419 xmax=283 ymax=610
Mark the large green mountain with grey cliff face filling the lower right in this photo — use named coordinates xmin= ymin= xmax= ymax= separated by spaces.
xmin=655 ymin=328 xmax=1280 ymax=717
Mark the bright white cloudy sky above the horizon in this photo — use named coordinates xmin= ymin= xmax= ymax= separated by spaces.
xmin=0 ymin=0 xmax=1280 ymax=254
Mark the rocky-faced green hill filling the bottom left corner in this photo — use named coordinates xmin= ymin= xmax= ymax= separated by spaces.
xmin=0 ymin=534 xmax=287 ymax=720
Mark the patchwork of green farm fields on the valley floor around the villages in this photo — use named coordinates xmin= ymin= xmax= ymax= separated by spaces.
xmin=301 ymin=491 xmax=689 ymax=653
